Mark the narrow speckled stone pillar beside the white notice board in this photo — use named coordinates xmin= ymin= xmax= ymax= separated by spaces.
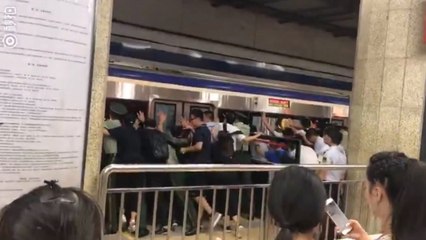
xmin=84 ymin=0 xmax=113 ymax=196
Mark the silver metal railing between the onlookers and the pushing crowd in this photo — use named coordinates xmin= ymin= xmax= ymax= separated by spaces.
xmin=98 ymin=164 xmax=366 ymax=240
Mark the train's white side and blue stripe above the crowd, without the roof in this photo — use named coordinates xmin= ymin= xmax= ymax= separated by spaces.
xmin=107 ymin=67 xmax=349 ymax=130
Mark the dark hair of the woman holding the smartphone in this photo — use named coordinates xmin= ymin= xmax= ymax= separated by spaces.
xmin=367 ymin=152 xmax=426 ymax=240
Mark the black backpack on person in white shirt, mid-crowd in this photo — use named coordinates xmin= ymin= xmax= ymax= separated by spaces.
xmin=216 ymin=122 xmax=243 ymax=163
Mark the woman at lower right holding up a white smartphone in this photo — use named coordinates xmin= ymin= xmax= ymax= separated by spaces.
xmin=345 ymin=152 xmax=426 ymax=240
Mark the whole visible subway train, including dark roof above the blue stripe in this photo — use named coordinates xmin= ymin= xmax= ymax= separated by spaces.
xmin=107 ymin=38 xmax=351 ymax=130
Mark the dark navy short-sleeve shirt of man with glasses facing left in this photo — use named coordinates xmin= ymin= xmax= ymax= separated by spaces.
xmin=188 ymin=125 xmax=212 ymax=164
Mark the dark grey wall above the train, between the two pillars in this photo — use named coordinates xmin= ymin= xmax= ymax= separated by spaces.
xmin=113 ymin=0 xmax=356 ymax=67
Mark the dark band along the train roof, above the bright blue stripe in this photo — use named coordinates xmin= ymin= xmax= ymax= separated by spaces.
xmin=110 ymin=42 xmax=352 ymax=91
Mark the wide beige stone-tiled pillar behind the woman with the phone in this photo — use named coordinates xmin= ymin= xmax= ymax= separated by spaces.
xmin=348 ymin=0 xmax=426 ymax=231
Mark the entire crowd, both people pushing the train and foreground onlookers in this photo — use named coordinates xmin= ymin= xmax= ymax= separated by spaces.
xmin=6 ymin=103 xmax=426 ymax=240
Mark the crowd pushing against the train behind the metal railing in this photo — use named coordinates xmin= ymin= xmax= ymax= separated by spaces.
xmin=102 ymin=103 xmax=346 ymax=237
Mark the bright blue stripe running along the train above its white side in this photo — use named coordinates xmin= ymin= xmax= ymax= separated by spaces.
xmin=109 ymin=67 xmax=349 ymax=105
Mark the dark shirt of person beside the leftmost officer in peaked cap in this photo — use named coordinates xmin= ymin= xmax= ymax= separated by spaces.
xmin=108 ymin=126 xmax=142 ymax=164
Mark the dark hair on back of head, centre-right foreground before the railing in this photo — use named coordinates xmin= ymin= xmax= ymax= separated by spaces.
xmin=268 ymin=166 xmax=327 ymax=240
